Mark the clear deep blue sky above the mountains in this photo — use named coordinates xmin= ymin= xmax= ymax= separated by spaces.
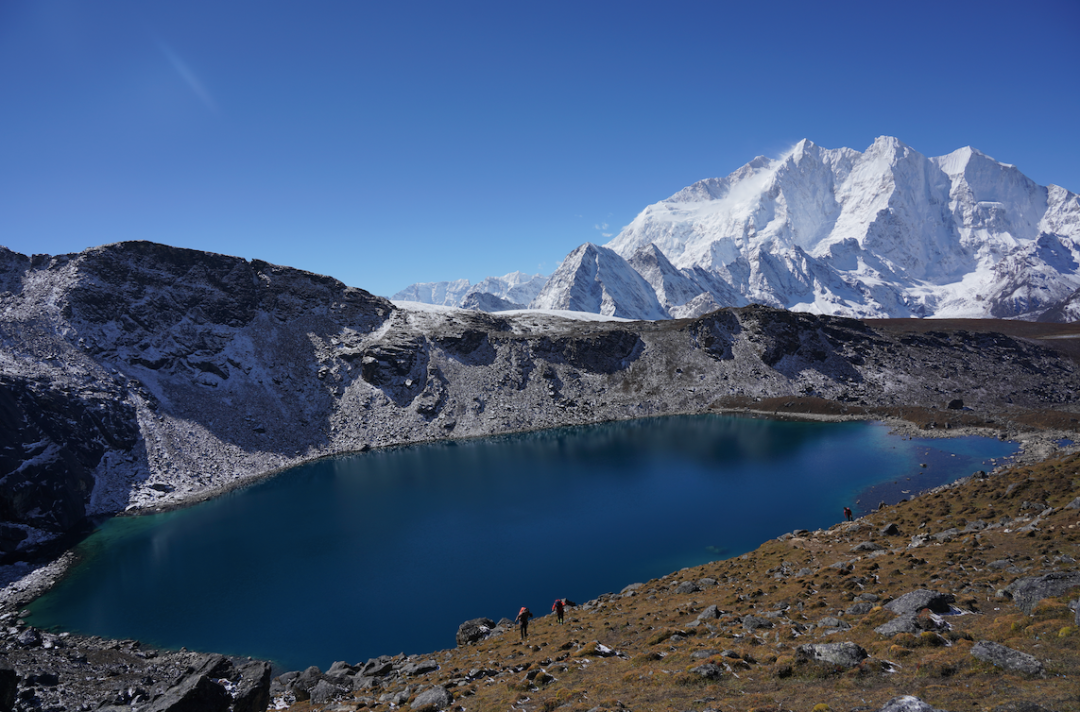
xmin=0 ymin=0 xmax=1080 ymax=296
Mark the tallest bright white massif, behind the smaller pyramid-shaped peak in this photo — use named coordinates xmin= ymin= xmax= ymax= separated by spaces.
xmin=607 ymin=136 xmax=1080 ymax=318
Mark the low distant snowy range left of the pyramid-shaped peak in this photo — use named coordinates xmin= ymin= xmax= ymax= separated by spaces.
xmin=391 ymin=272 xmax=548 ymax=311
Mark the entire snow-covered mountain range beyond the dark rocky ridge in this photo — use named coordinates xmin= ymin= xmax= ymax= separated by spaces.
xmin=394 ymin=137 xmax=1080 ymax=322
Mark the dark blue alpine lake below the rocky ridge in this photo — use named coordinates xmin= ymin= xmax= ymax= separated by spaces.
xmin=31 ymin=416 xmax=1015 ymax=670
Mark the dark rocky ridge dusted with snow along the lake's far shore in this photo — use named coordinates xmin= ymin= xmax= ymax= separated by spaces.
xmin=0 ymin=242 xmax=1080 ymax=556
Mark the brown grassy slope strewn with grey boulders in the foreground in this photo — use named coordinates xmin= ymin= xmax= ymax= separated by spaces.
xmin=293 ymin=455 xmax=1080 ymax=712
